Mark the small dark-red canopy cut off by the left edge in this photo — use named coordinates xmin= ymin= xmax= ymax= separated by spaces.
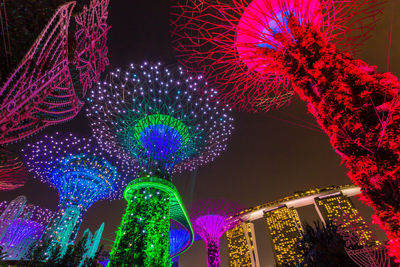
xmin=0 ymin=147 xmax=28 ymax=191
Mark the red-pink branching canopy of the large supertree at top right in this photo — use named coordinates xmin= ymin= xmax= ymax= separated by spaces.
xmin=171 ymin=0 xmax=385 ymax=111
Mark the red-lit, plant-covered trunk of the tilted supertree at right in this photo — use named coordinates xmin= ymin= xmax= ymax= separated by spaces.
xmin=260 ymin=17 xmax=400 ymax=260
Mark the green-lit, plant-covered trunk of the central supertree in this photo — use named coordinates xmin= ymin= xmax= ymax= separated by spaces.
xmin=109 ymin=186 xmax=171 ymax=267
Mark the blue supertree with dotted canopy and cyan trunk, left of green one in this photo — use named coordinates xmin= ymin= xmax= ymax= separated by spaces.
xmin=23 ymin=133 xmax=134 ymax=254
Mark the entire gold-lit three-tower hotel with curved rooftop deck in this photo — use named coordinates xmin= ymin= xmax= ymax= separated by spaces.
xmin=227 ymin=185 xmax=379 ymax=267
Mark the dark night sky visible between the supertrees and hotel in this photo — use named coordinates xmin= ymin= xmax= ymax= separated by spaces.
xmin=5 ymin=0 xmax=400 ymax=267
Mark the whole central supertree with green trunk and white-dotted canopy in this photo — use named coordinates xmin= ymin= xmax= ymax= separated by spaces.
xmin=88 ymin=63 xmax=233 ymax=266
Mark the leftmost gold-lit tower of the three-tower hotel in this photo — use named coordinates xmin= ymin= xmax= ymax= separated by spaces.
xmin=226 ymin=222 xmax=260 ymax=267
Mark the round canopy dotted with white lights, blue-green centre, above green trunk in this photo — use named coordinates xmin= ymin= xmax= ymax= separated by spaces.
xmin=87 ymin=63 xmax=233 ymax=174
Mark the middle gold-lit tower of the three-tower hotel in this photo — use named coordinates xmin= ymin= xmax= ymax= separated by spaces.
xmin=264 ymin=205 xmax=303 ymax=266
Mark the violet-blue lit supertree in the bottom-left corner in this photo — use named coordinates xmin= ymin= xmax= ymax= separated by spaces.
xmin=0 ymin=205 xmax=54 ymax=260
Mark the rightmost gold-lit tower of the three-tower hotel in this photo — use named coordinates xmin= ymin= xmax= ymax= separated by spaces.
xmin=315 ymin=192 xmax=380 ymax=246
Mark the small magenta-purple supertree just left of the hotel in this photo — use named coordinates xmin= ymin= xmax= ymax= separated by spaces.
xmin=190 ymin=199 xmax=243 ymax=267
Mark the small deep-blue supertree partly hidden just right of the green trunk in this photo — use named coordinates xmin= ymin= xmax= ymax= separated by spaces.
xmin=169 ymin=222 xmax=190 ymax=267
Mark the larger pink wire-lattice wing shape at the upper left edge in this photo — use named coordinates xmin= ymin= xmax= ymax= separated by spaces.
xmin=0 ymin=2 xmax=79 ymax=144
